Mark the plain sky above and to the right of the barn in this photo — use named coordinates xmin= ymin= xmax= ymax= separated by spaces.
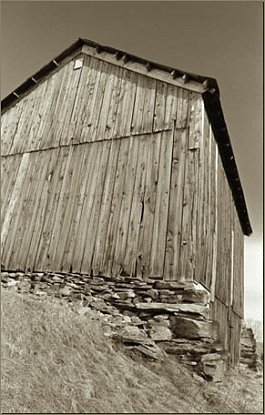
xmin=1 ymin=1 xmax=263 ymax=320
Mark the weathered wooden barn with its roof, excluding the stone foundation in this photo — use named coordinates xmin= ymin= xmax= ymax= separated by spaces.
xmin=1 ymin=39 xmax=251 ymax=363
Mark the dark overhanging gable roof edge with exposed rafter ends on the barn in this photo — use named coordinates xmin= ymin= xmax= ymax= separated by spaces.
xmin=1 ymin=38 xmax=252 ymax=235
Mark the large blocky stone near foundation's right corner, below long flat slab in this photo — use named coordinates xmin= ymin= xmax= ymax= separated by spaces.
xmin=170 ymin=316 xmax=217 ymax=339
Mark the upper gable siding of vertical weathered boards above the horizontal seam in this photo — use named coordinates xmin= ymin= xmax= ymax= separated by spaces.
xmin=2 ymin=55 xmax=190 ymax=156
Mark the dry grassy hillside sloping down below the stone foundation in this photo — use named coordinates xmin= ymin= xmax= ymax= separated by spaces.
xmin=1 ymin=289 xmax=262 ymax=413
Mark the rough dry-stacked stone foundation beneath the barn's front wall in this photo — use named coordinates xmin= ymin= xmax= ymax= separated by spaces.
xmin=1 ymin=272 xmax=226 ymax=381
